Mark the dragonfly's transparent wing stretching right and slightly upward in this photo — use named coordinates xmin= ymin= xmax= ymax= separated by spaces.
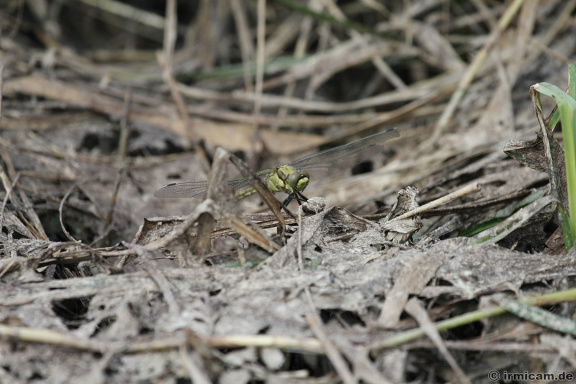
xmin=289 ymin=128 xmax=400 ymax=170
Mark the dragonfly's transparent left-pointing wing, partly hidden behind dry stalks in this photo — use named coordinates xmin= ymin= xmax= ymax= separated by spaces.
xmin=154 ymin=169 xmax=274 ymax=199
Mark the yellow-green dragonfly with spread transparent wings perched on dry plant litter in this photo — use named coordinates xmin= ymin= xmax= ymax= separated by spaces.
xmin=154 ymin=128 xmax=400 ymax=207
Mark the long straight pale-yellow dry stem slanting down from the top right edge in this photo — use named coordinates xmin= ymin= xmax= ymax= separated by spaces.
xmin=424 ymin=0 xmax=525 ymax=147
